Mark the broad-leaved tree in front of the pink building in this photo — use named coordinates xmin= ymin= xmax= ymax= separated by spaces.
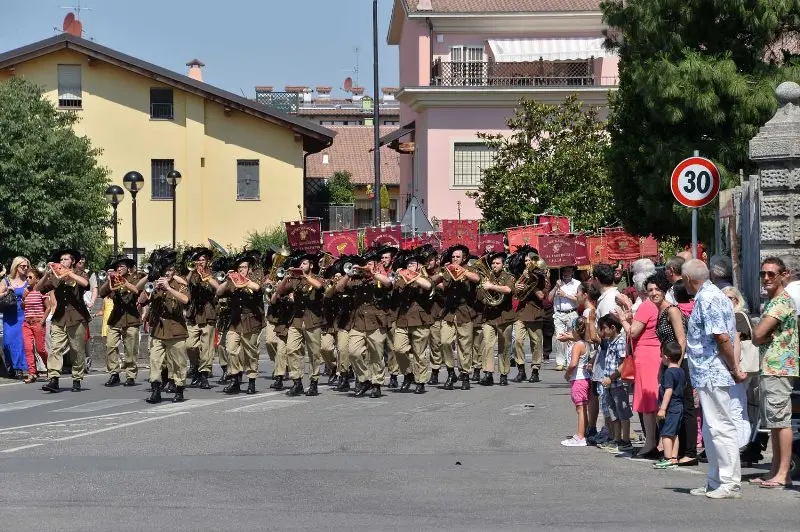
xmin=470 ymin=95 xmax=617 ymax=230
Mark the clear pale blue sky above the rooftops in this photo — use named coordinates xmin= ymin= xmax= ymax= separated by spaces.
xmin=0 ymin=0 xmax=399 ymax=96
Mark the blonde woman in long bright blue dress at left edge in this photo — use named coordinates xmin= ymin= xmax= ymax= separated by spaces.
xmin=0 ymin=257 xmax=31 ymax=379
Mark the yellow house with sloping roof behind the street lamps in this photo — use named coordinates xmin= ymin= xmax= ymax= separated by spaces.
xmin=0 ymin=33 xmax=335 ymax=256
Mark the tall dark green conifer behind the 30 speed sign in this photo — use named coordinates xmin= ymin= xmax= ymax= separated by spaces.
xmin=602 ymin=0 xmax=800 ymax=235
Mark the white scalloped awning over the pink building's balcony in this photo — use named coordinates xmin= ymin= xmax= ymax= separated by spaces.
xmin=489 ymin=37 xmax=611 ymax=63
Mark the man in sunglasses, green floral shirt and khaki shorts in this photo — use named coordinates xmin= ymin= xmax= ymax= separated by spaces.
xmin=753 ymin=257 xmax=798 ymax=489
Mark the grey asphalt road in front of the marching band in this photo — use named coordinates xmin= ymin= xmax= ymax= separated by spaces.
xmin=0 ymin=362 xmax=800 ymax=532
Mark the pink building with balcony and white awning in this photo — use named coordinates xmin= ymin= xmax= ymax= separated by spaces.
xmin=382 ymin=0 xmax=617 ymax=224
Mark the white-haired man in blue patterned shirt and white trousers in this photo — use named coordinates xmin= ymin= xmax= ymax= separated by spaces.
xmin=682 ymin=259 xmax=747 ymax=499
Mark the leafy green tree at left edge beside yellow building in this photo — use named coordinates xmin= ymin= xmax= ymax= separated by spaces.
xmin=0 ymin=77 xmax=110 ymax=268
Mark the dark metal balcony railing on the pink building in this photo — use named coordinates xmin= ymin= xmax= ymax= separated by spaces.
xmin=431 ymin=60 xmax=617 ymax=87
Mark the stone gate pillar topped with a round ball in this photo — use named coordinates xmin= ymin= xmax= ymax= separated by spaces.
xmin=750 ymin=82 xmax=800 ymax=260
